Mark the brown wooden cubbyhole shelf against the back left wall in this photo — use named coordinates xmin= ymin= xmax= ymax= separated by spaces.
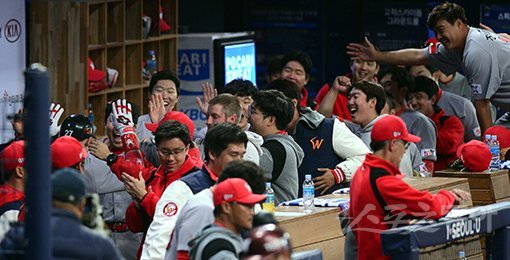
xmin=28 ymin=0 xmax=178 ymax=136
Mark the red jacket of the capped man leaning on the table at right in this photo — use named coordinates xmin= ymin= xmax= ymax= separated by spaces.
xmin=349 ymin=154 xmax=455 ymax=260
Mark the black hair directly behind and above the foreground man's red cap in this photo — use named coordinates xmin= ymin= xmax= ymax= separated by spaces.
xmin=217 ymin=160 xmax=266 ymax=194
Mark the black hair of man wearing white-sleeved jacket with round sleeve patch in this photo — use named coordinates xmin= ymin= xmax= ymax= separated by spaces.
xmin=203 ymin=123 xmax=248 ymax=161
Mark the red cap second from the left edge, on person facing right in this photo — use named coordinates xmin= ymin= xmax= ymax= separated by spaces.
xmin=51 ymin=136 xmax=88 ymax=169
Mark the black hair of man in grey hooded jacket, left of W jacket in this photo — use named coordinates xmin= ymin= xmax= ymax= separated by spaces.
xmin=253 ymin=89 xmax=294 ymax=130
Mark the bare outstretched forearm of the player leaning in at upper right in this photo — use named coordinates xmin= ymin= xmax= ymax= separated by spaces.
xmin=376 ymin=49 xmax=428 ymax=65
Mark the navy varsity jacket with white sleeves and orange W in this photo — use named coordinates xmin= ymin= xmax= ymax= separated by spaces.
xmin=291 ymin=108 xmax=370 ymax=195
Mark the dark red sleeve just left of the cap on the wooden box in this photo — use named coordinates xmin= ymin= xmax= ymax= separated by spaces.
xmin=436 ymin=116 xmax=464 ymax=154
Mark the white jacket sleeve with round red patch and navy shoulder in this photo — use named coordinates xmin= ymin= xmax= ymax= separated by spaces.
xmin=141 ymin=164 xmax=218 ymax=260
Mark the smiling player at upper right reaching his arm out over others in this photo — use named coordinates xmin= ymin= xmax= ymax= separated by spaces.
xmin=347 ymin=3 xmax=510 ymax=133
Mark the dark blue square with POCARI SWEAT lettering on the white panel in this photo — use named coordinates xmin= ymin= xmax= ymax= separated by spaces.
xmin=178 ymin=49 xmax=210 ymax=81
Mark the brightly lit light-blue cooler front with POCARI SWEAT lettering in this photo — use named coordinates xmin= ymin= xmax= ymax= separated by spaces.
xmin=225 ymin=42 xmax=257 ymax=84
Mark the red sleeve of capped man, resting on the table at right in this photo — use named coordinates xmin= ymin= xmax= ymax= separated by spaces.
xmin=377 ymin=176 xmax=455 ymax=219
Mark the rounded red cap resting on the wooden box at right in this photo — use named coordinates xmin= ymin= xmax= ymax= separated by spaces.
xmin=457 ymin=140 xmax=492 ymax=172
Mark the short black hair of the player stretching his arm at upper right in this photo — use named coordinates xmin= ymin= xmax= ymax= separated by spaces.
xmin=427 ymin=2 xmax=467 ymax=30
